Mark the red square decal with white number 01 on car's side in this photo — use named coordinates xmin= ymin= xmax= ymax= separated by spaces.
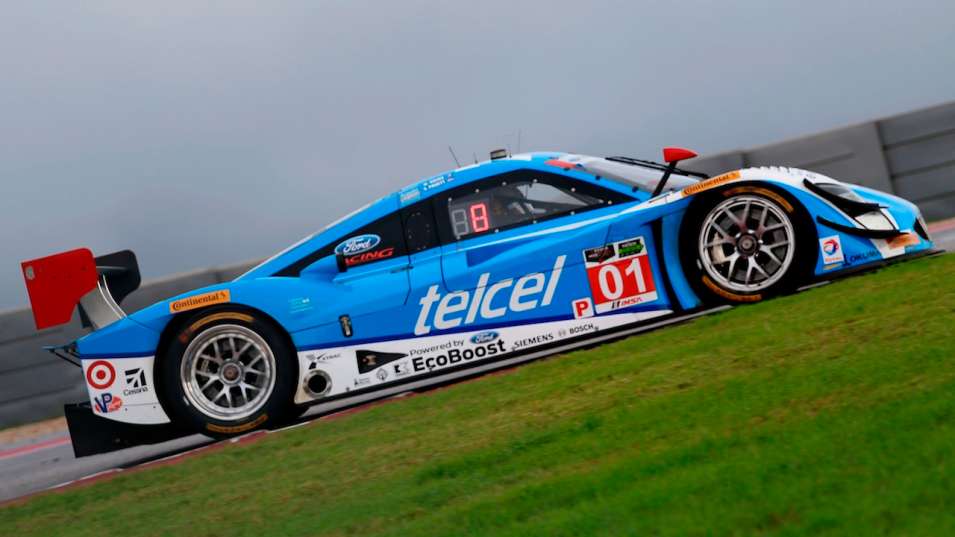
xmin=584 ymin=237 xmax=657 ymax=313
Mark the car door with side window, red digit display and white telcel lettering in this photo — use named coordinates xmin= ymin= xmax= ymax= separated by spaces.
xmin=415 ymin=168 xmax=632 ymax=335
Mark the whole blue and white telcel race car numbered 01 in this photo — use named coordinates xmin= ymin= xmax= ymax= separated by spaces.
xmin=22 ymin=148 xmax=933 ymax=455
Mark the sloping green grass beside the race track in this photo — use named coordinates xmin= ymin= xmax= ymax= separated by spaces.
xmin=0 ymin=255 xmax=955 ymax=537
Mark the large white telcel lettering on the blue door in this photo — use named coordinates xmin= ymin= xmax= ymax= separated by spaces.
xmin=414 ymin=255 xmax=567 ymax=336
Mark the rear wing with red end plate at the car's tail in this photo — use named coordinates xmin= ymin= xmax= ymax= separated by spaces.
xmin=20 ymin=248 xmax=141 ymax=330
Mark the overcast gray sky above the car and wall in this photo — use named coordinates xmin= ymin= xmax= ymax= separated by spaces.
xmin=0 ymin=0 xmax=955 ymax=308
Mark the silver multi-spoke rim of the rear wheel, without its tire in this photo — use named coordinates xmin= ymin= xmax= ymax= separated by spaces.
xmin=180 ymin=324 xmax=275 ymax=421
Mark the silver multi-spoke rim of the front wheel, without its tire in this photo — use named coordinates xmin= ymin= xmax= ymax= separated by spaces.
xmin=699 ymin=196 xmax=796 ymax=293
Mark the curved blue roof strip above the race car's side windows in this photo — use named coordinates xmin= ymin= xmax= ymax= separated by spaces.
xmin=237 ymin=151 xmax=658 ymax=280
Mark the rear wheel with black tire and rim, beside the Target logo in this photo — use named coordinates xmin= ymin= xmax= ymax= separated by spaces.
xmin=156 ymin=308 xmax=298 ymax=438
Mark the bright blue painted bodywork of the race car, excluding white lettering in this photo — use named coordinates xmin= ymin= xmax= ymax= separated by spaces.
xmin=77 ymin=153 xmax=931 ymax=358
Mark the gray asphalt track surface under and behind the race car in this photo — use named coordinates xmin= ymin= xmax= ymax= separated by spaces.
xmin=0 ymin=219 xmax=955 ymax=502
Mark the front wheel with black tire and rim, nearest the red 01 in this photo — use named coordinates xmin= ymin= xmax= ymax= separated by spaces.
xmin=680 ymin=185 xmax=816 ymax=304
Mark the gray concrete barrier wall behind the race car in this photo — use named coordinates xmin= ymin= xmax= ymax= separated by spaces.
xmin=0 ymin=102 xmax=955 ymax=427
